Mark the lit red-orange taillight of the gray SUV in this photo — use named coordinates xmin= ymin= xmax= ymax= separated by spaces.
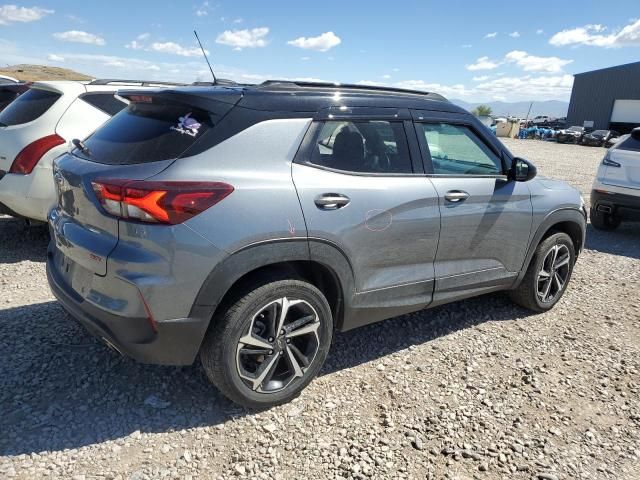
xmin=91 ymin=179 xmax=233 ymax=225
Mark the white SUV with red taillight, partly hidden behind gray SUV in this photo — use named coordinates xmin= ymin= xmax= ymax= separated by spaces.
xmin=0 ymin=80 xmax=182 ymax=221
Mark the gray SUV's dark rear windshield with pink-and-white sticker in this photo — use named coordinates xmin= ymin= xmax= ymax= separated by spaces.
xmin=74 ymin=103 xmax=213 ymax=165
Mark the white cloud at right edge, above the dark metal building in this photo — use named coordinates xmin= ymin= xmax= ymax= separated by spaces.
xmin=549 ymin=19 xmax=640 ymax=48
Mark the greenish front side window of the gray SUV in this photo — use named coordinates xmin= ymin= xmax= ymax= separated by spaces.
xmin=418 ymin=123 xmax=502 ymax=175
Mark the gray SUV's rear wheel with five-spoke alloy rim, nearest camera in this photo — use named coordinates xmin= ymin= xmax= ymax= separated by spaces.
xmin=200 ymin=280 xmax=333 ymax=409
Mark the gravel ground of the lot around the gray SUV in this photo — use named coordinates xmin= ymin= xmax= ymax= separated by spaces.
xmin=0 ymin=140 xmax=640 ymax=480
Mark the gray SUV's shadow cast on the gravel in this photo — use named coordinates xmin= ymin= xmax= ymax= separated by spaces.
xmin=0 ymin=295 xmax=527 ymax=455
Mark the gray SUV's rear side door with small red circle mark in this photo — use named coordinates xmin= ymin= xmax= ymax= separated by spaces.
xmin=292 ymin=108 xmax=440 ymax=326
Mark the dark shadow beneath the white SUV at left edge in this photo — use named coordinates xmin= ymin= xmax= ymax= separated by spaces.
xmin=0 ymin=216 xmax=49 ymax=264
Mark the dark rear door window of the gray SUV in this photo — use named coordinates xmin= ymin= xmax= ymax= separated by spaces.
xmin=311 ymin=120 xmax=412 ymax=173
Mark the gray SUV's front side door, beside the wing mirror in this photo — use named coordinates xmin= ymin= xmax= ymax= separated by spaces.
xmin=414 ymin=112 xmax=532 ymax=302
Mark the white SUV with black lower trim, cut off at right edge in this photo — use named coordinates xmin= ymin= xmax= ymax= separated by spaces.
xmin=591 ymin=128 xmax=640 ymax=230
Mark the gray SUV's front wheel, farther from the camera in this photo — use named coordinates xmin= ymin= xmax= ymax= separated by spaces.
xmin=509 ymin=232 xmax=576 ymax=312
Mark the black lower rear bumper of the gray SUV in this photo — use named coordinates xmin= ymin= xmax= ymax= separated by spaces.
xmin=47 ymin=246 xmax=210 ymax=365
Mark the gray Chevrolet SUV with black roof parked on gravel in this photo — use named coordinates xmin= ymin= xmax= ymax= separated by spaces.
xmin=47 ymin=81 xmax=586 ymax=408
